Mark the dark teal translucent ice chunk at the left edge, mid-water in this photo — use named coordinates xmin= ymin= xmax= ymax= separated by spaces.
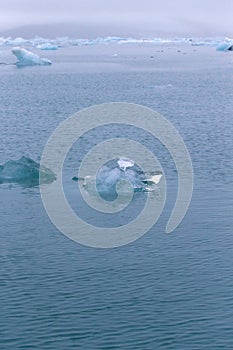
xmin=0 ymin=156 xmax=56 ymax=186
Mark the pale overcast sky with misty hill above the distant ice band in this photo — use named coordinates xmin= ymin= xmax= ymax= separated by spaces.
xmin=0 ymin=0 xmax=233 ymax=37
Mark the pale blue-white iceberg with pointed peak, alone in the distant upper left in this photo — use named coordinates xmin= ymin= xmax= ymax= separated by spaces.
xmin=11 ymin=47 xmax=52 ymax=67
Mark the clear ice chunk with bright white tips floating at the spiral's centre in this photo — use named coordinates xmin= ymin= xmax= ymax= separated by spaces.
xmin=73 ymin=157 xmax=162 ymax=196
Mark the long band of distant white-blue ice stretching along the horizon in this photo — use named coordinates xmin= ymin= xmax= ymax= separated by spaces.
xmin=0 ymin=36 xmax=230 ymax=50
